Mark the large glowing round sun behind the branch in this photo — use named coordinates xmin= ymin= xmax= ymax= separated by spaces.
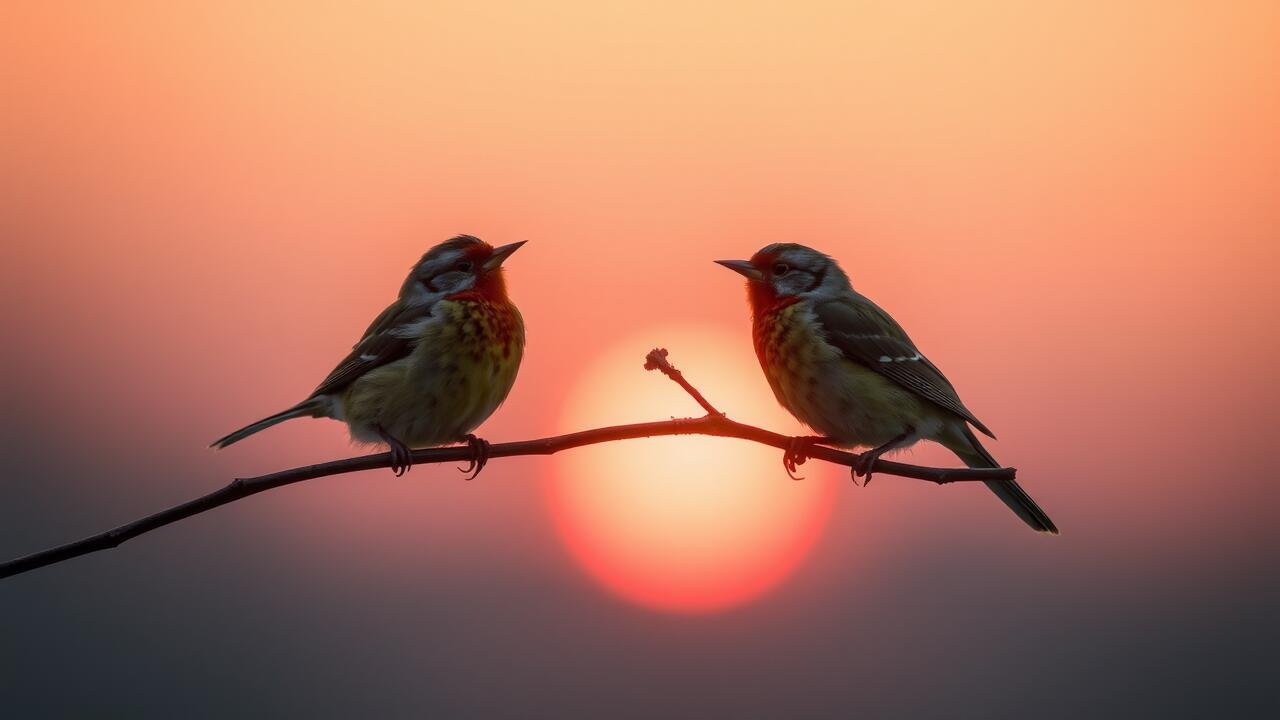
xmin=549 ymin=327 xmax=833 ymax=612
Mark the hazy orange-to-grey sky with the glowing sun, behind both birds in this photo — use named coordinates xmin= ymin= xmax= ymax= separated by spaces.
xmin=0 ymin=1 xmax=1280 ymax=717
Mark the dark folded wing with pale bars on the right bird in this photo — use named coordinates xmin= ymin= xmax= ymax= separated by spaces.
xmin=813 ymin=293 xmax=996 ymax=437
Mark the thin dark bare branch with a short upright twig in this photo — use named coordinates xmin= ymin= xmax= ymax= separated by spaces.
xmin=0 ymin=348 xmax=1016 ymax=578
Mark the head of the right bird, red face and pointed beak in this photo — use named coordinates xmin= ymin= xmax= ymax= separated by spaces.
xmin=717 ymin=242 xmax=850 ymax=311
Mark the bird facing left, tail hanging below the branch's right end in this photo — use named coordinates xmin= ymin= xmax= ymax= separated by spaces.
xmin=717 ymin=242 xmax=1059 ymax=534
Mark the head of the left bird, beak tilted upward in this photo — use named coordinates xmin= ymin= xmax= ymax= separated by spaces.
xmin=401 ymin=234 xmax=526 ymax=304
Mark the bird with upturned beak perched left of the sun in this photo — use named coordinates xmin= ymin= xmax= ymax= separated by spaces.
xmin=211 ymin=234 xmax=525 ymax=477
